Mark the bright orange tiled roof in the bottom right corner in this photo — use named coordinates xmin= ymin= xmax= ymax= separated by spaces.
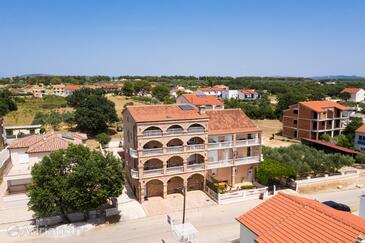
xmin=237 ymin=193 xmax=365 ymax=243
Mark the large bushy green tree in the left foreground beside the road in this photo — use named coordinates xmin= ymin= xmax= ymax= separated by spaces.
xmin=27 ymin=145 xmax=124 ymax=219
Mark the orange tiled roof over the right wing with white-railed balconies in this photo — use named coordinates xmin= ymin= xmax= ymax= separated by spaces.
xmin=206 ymin=109 xmax=261 ymax=134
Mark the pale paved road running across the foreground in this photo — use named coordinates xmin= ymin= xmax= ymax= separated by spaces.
xmin=0 ymin=189 xmax=364 ymax=243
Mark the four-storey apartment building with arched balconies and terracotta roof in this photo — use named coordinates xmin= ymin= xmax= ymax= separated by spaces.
xmin=123 ymin=104 xmax=261 ymax=202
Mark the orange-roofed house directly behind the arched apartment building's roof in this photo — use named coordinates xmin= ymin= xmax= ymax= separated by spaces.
xmin=176 ymin=94 xmax=224 ymax=110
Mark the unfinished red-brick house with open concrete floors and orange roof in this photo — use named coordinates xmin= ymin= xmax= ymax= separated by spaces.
xmin=283 ymin=101 xmax=349 ymax=140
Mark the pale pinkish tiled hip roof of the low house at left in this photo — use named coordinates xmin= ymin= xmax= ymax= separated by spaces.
xmin=9 ymin=133 xmax=87 ymax=153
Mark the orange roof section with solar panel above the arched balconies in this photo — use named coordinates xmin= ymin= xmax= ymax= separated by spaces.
xmin=123 ymin=104 xmax=207 ymax=122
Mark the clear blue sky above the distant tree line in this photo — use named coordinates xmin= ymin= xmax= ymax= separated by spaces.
xmin=0 ymin=0 xmax=365 ymax=76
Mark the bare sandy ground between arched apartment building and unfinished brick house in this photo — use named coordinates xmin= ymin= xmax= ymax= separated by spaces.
xmin=253 ymin=120 xmax=299 ymax=147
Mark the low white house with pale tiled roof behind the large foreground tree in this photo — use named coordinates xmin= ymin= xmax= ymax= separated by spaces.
xmin=4 ymin=133 xmax=87 ymax=193
